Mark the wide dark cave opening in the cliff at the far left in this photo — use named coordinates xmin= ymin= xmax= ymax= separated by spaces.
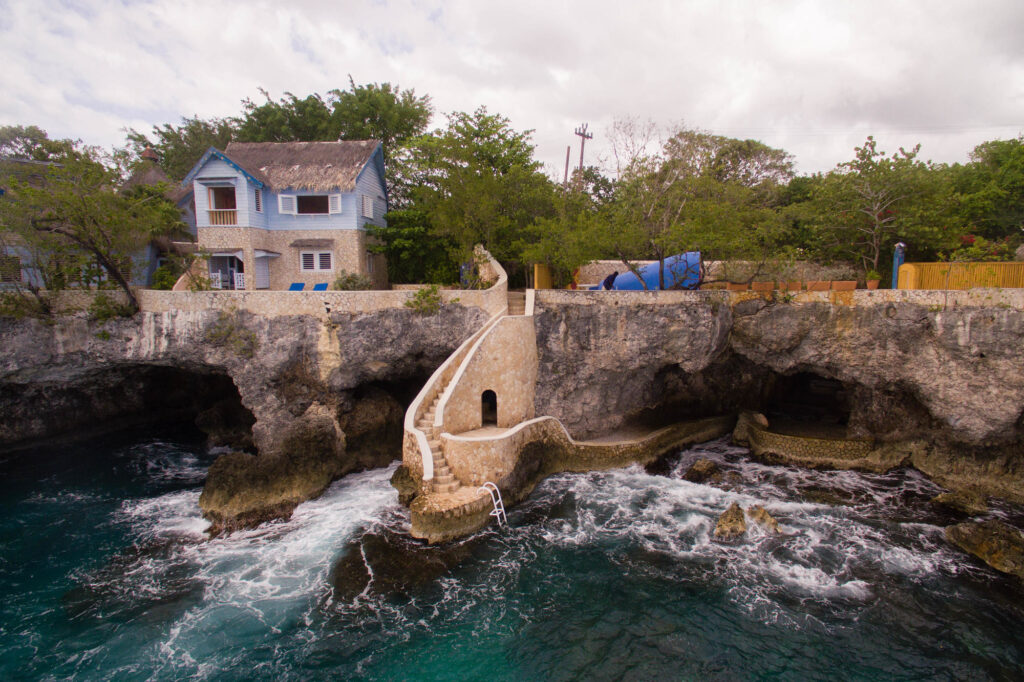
xmin=0 ymin=365 xmax=256 ymax=452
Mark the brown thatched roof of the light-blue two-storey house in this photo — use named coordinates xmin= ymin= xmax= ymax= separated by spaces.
xmin=224 ymin=139 xmax=380 ymax=191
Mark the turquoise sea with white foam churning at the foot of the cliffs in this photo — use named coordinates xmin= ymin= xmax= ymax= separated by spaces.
xmin=0 ymin=434 xmax=1024 ymax=680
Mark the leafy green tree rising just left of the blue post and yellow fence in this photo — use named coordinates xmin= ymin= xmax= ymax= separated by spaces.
xmin=815 ymin=136 xmax=955 ymax=271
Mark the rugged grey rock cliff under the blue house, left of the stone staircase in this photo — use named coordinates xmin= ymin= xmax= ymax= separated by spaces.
xmin=0 ymin=305 xmax=486 ymax=530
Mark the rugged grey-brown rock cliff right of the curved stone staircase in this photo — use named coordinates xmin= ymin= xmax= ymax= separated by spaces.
xmin=535 ymin=292 xmax=1024 ymax=500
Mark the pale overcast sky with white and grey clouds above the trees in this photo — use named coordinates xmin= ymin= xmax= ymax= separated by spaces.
xmin=0 ymin=0 xmax=1024 ymax=178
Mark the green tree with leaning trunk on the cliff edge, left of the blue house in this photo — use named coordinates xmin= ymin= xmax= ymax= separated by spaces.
xmin=0 ymin=143 xmax=183 ymax=311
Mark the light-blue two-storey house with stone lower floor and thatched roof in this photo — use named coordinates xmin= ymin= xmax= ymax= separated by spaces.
xmin=182 ymin=140 xmax=387 ymax=290
